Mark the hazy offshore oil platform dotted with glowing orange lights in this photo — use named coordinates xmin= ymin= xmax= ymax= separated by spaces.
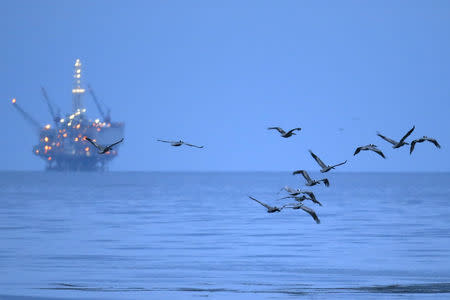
xmin=12 ymin=59 xmax=124 ymax=171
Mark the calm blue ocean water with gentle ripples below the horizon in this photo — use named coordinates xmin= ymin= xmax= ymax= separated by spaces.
xmin=0 ymin=172 xmax=450 ymax=300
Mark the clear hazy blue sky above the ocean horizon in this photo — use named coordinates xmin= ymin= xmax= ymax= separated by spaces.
xmin=0 ymin=0 xmax=450 ymax=171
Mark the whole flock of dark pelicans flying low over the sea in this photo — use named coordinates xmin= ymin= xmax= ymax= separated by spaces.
xmin=85 ymin=126 xmax=441 ymax=224
